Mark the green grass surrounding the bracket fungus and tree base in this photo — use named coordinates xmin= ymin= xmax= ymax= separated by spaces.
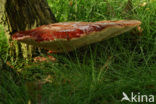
xmin=0 ymin=0 xmax=156 ymax=104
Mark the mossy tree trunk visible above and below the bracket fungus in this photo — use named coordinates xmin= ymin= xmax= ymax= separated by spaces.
xmin=0 ymin=0 xmax=56 ymax=59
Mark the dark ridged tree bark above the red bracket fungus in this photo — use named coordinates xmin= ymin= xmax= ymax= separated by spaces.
xmin=5 ymin=0 xmax=56 ymax=33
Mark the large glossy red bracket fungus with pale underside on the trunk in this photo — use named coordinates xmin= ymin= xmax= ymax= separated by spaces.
xmin=12 ymin=20 xmax=141 ymax=52
